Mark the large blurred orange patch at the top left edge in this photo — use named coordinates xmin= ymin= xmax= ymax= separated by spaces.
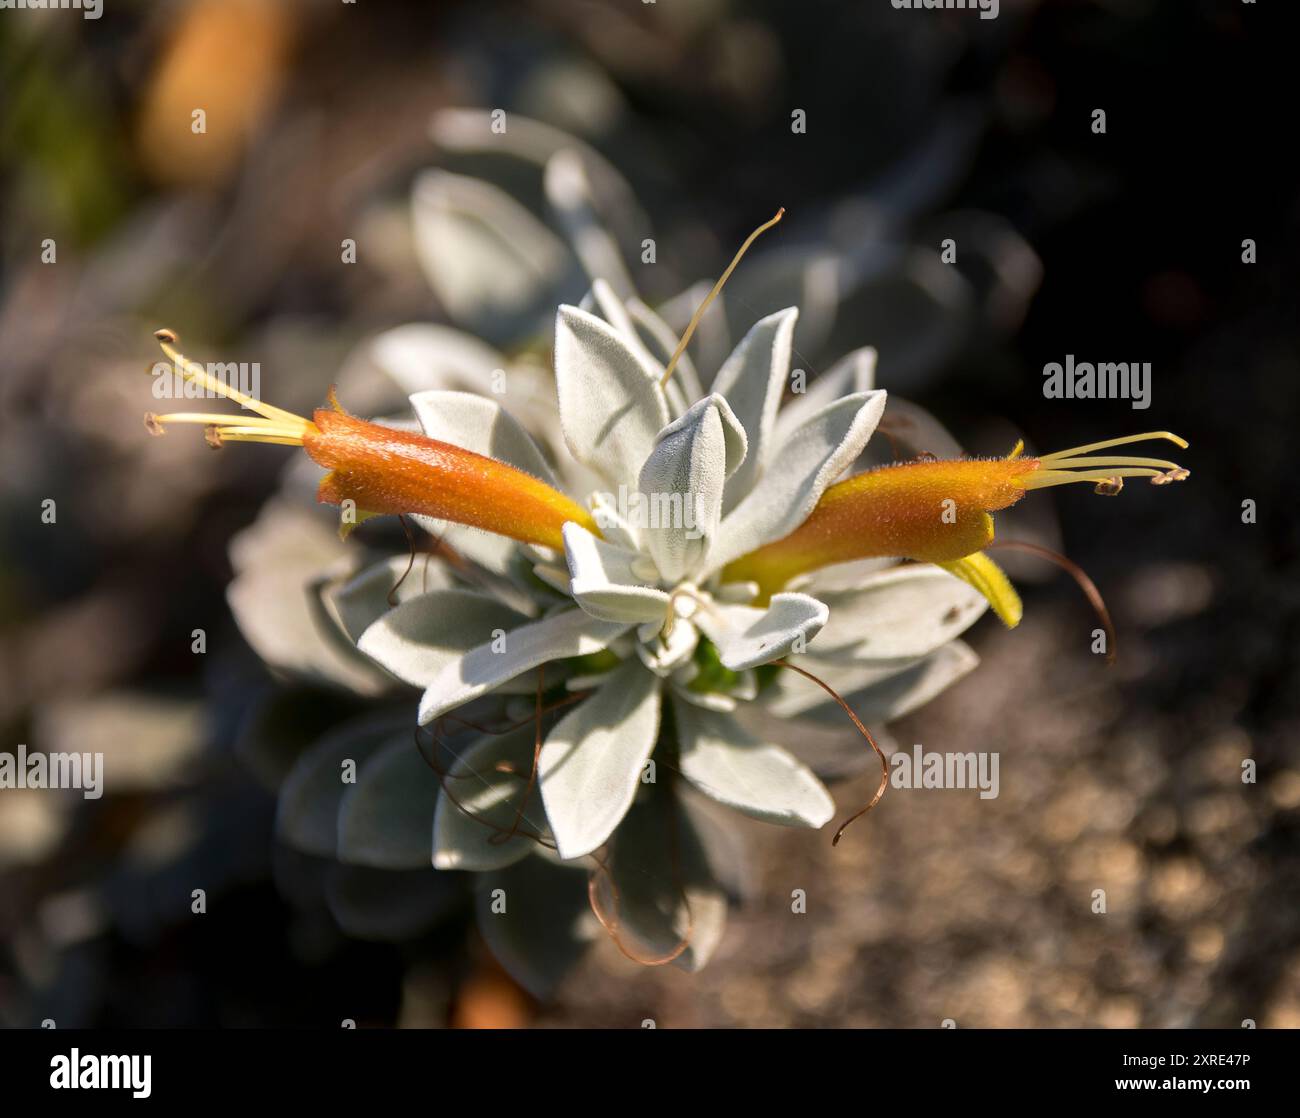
xmin=137 ymin=0 xmax=295 ymax=186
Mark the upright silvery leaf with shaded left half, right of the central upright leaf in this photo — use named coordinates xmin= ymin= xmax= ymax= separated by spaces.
xmin=714 ymin=307 xmax=800 ymax=511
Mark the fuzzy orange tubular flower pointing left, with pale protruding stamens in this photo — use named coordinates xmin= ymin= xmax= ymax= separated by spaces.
xmin=146 ymin=330 xmax=599 ymax=551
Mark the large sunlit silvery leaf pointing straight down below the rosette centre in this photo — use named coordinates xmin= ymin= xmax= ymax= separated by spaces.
xmin=538 ymin=659 xmax=660 ymax=858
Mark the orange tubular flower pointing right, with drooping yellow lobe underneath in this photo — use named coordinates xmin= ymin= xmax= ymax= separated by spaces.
xmin=723 ymin=432 xmax=1188 ymax=616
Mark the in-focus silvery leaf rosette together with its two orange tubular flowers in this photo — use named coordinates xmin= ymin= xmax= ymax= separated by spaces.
xmin=148 ymin=208 xmax=1186 ymax=966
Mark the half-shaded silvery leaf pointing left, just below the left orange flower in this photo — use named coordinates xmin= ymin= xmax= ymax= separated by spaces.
xmin=356 ymin=590 xmax=528 ymax=688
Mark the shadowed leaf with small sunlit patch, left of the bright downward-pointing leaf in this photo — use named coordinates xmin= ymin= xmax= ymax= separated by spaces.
xmin=425 ymin=723 xmax=549 ymax=871
